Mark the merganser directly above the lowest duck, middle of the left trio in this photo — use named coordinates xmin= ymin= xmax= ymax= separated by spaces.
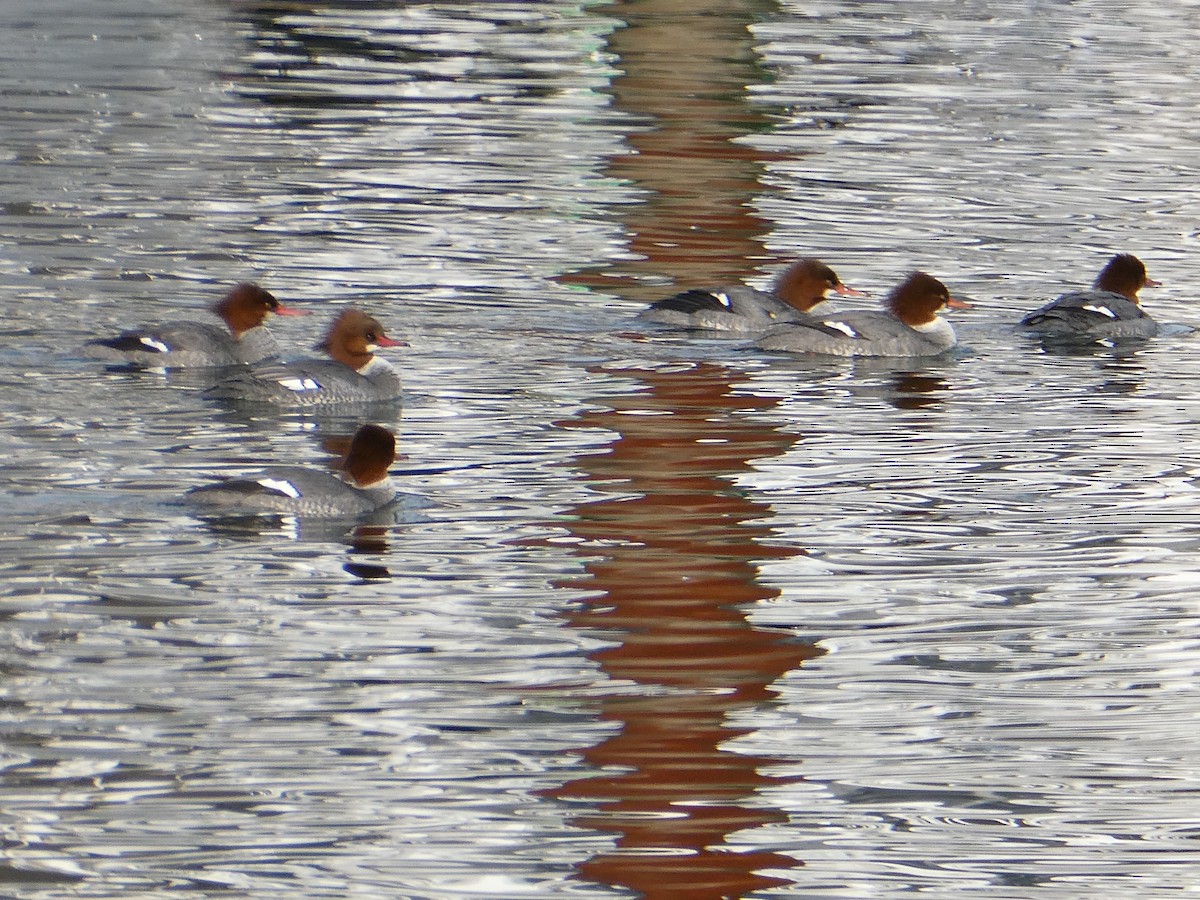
xmin=205 ymin=307 xmax=408 ymax=407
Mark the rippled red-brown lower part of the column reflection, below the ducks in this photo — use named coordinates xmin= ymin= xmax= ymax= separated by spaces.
xmin=553 ymin=364 xmax=820 ymax=899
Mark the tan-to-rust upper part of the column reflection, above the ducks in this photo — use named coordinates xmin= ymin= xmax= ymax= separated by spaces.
xmin=564 ymin=0 xmax=787 ymax=300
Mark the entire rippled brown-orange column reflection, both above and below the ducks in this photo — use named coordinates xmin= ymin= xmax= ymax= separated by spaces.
xmin=553 ymin=0 xmax=818 ymax=900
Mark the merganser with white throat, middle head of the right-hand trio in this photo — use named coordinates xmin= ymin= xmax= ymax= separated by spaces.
xmin=757 ymin=272 xmax=971 ymax=356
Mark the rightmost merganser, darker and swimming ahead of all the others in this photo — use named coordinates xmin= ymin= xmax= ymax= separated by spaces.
xmin=1018 ymin=253 xmax=1159 ymax=341
